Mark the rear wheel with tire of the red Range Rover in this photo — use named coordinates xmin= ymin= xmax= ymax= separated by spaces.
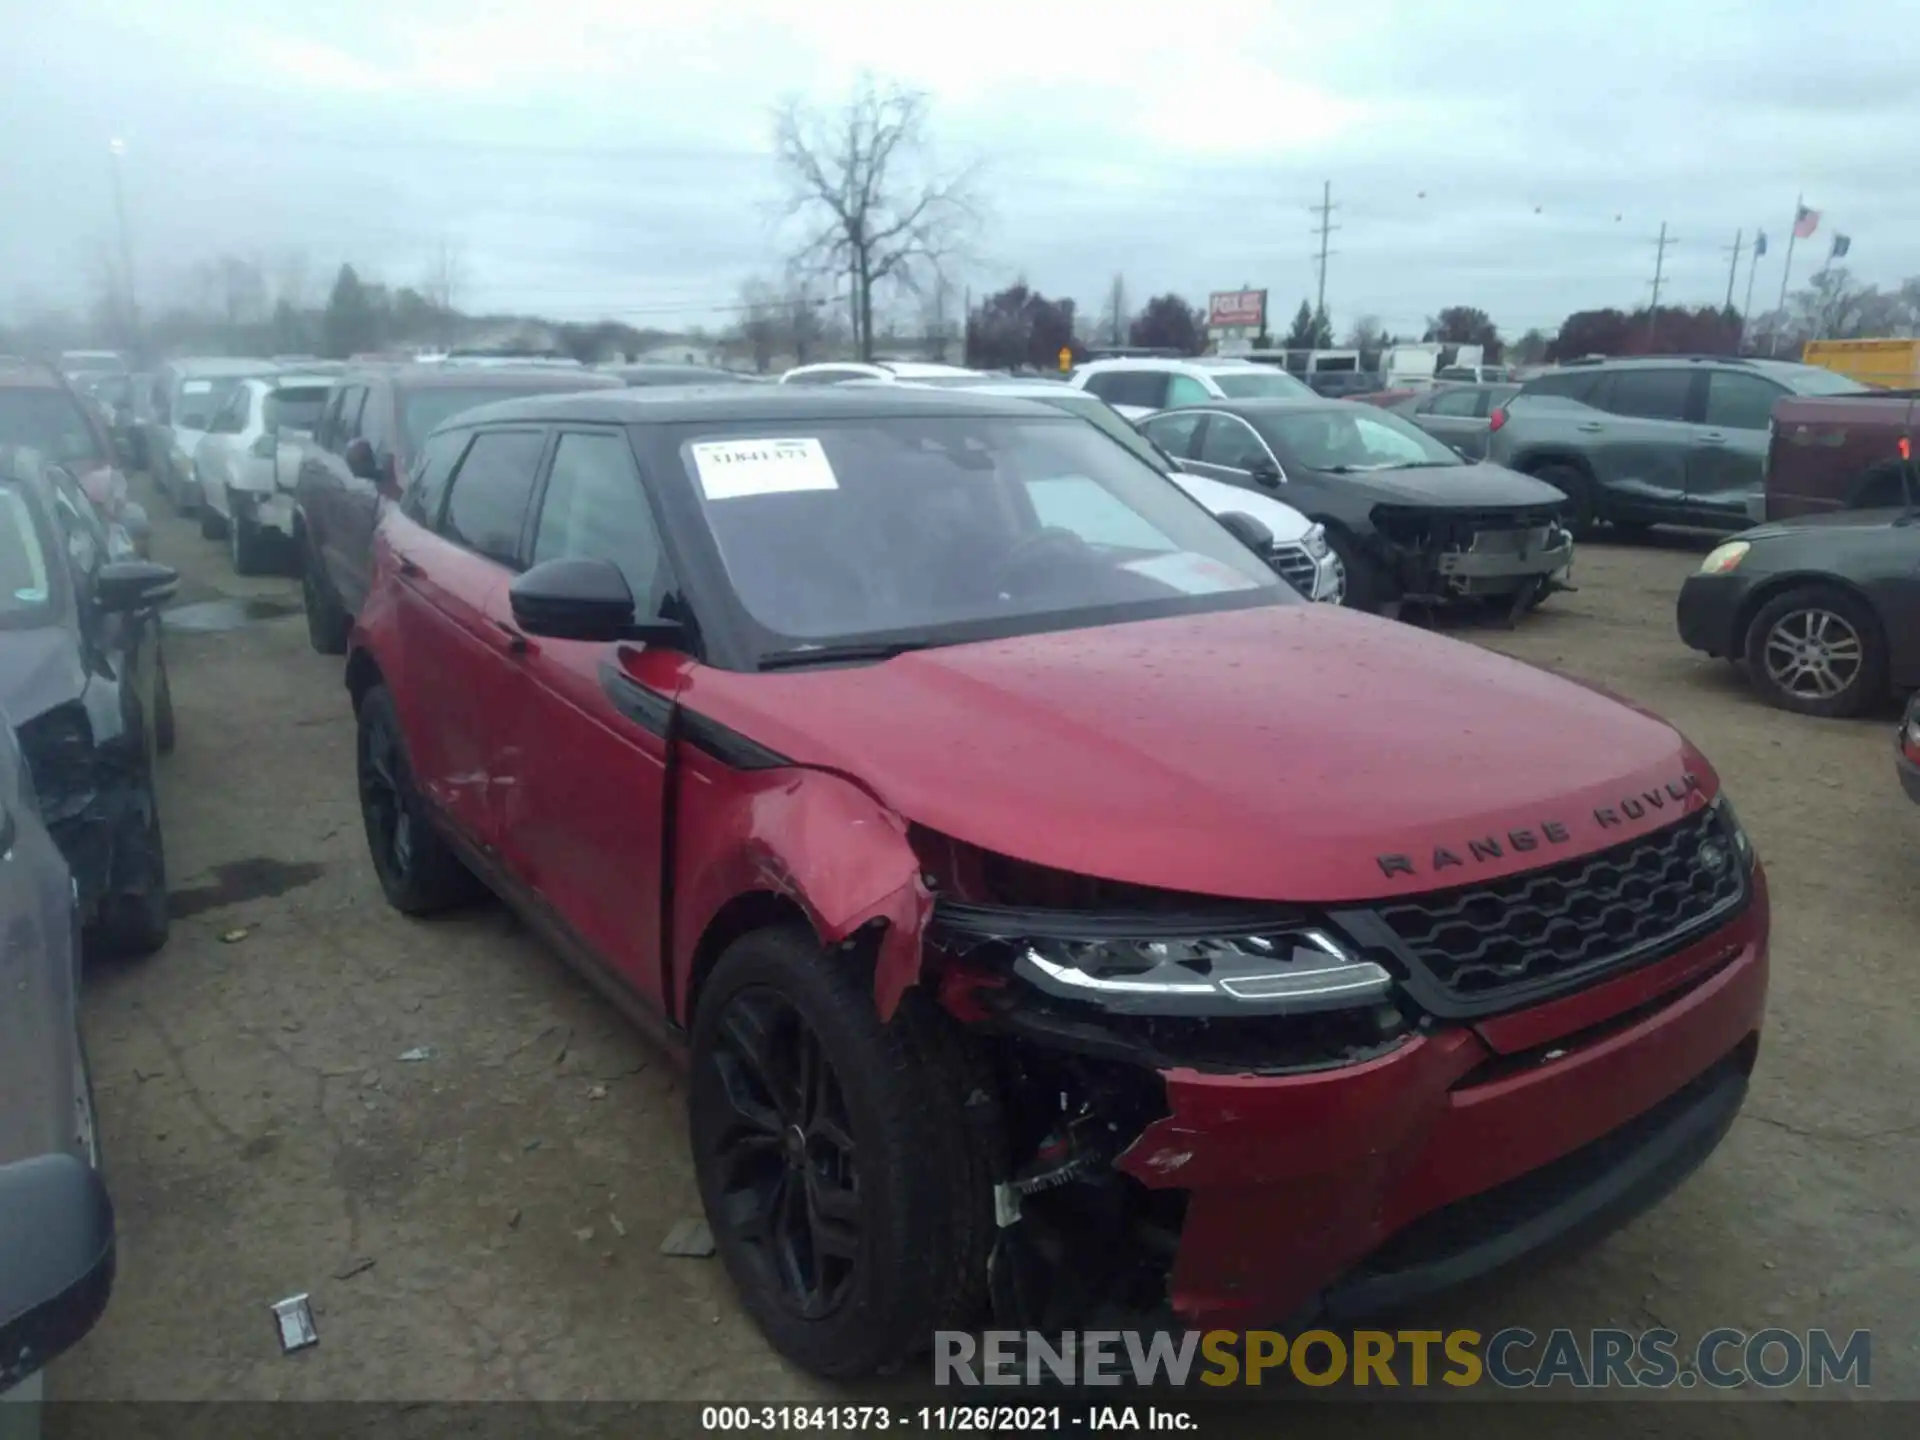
xmin=357 ymin=685 xmax=486 ymax=916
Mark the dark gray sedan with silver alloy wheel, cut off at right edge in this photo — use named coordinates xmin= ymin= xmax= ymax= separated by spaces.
xmin=1676 ymin=511 xmax=1920 ymax=716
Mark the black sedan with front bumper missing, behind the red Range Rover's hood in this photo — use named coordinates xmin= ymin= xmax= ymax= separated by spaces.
xmin=1140 ymin=399 xmax=1572 ymax=612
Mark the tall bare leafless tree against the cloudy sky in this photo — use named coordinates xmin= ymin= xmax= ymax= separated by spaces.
xmin=774 ymin=77 xmax=977 ymax=359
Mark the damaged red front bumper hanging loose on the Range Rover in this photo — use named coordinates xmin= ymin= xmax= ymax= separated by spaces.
xmin=935 ymin=872 xmax=1766 ymax=1329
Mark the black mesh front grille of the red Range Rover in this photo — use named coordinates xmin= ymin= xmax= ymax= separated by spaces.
xmin=1380 ymin=810 xmax=1747 ymax=1008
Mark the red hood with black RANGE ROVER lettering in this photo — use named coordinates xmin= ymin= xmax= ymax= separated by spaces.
xmin=682 ymin=605 xmax=1716 ymax=902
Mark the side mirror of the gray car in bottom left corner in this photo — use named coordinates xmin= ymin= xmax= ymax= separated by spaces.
xmin=0 ymin=1154 xmax=113 ymax=1404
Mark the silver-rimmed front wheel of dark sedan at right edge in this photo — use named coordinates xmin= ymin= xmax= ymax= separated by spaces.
xmin=1741 ymin=584 xmax=1887 ymax=720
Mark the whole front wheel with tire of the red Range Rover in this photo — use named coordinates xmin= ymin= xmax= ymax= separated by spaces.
xmin=687 ymin=925 xmax=995 ymax=1379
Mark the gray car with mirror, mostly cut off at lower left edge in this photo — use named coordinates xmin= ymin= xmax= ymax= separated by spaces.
xmin=0 ymin=716 xmax=113 ymax=1436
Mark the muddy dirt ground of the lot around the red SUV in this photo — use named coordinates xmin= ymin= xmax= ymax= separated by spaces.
xmin=48 ymin=487 xmax=1920 ymax=1423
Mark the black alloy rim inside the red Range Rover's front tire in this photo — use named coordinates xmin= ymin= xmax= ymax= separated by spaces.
xmin=707 ymin=987 xmax=860 ymax=1319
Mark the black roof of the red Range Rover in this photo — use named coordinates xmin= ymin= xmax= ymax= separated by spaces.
xmin=449 ymin=384 xmax=1060 ymax=426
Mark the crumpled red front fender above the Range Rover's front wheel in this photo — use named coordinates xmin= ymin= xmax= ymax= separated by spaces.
xmin=672 ymin=753 xmax=933 ymax=1020
